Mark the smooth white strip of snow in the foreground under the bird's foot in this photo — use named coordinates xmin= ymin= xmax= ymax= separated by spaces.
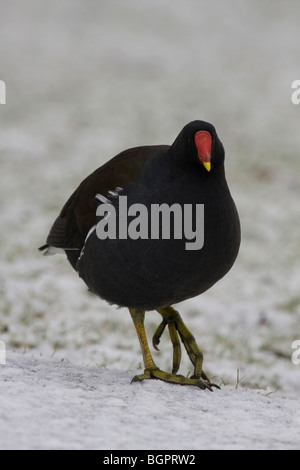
xmin=0 ymin=353 xmax=300 ymax=450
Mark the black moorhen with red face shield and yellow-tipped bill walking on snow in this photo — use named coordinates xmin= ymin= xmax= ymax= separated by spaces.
xmin=40 ymin=121 xmax=240 ymax=390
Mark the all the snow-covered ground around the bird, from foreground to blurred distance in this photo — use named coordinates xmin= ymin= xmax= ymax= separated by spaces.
xmin=0 ymin=0 xmax=300 ymax=449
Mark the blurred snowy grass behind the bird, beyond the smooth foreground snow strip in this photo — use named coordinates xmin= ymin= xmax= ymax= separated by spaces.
xmin=0 ymin=0 xmax=300 ymax=395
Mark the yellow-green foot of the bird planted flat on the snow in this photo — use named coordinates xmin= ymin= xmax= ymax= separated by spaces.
xmin=132 ymin=368 xmax=220 ymax=392
